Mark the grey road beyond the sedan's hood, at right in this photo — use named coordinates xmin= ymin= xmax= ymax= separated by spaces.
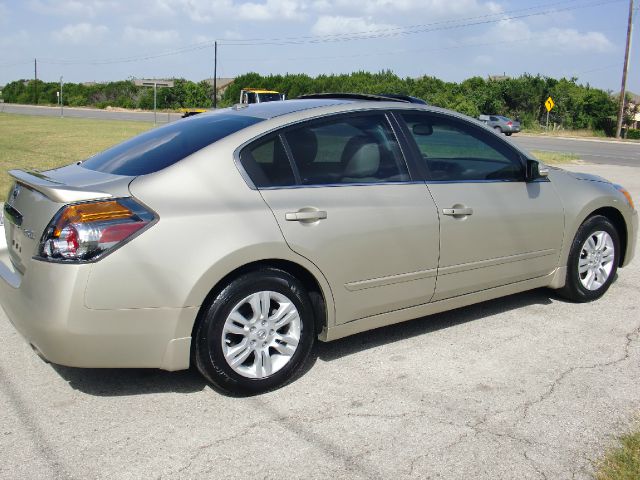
xmin=510 ymin=135 xmax=640 ymax=167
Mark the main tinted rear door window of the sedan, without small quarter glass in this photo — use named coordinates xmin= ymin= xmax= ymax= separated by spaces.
xmin=284 ymin=114 xmax=409 ymax=185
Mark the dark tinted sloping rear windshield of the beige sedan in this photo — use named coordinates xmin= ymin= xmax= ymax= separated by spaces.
xmin=82 ymin=113 xmax=263 ymax=176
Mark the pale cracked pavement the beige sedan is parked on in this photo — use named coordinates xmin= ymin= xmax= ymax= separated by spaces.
xmin=0 ymin=165 xmax=640 ymax=480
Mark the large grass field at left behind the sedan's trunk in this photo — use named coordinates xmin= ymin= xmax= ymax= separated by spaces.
xmin=0 ymin=113 xmax=153 ymax=201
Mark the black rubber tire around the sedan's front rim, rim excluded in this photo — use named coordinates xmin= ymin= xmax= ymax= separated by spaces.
xmin=557 ymin=215 xmax=620 ymax=302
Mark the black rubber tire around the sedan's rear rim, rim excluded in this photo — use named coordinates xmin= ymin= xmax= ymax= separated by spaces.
xmin=194 ymin=268 xmax=315 ymax=395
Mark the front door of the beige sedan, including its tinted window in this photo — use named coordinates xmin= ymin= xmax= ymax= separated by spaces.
xmin=399 ymin=112 xmax=564 ymax=301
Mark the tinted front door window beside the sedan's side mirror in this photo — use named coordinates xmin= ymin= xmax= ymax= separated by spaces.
xmin=401 ymin=113 xmax=524 ymax=181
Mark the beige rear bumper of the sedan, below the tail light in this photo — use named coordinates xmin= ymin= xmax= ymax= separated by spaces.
xmin=0 ymin=245 xmax=198 ymax=371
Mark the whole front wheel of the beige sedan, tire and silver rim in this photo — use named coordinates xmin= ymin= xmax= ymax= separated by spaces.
xmin=558 ymin=216 xmax=620 ymax=302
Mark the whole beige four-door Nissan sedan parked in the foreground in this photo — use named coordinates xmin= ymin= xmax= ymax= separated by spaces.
xmin=0 ymin=95 xmax=638 ymax=394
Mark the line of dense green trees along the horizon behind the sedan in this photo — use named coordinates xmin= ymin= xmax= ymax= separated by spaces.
xmin=2 ymin=71 xmax=631 ymax=134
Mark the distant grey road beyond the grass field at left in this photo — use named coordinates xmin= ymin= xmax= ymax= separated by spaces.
xmin=0 ymin=103 xmax=181 ymax=123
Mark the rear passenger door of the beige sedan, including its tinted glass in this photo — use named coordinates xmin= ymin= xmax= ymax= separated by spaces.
xmin=241 ymin=113 xmax=439 ymax=323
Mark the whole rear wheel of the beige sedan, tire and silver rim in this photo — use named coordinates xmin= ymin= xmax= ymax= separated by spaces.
xmin=194 ymin=268 xmax=315 ymax=395
